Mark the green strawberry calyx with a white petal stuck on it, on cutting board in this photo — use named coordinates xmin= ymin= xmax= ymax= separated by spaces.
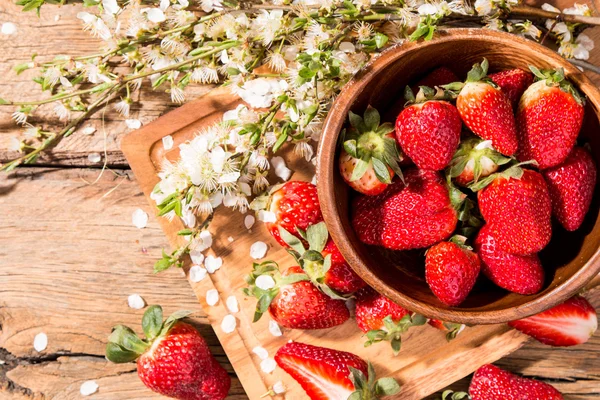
xmin=243 ymin=261 xmax=309 ymax=322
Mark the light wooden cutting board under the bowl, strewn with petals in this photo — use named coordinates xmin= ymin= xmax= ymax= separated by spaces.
xmin=121 ymin=88 xmax=599 ymax=400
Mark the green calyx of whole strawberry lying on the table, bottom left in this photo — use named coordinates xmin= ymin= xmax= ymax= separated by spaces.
xmin=106 ymin=305 xmax=192 ymax=364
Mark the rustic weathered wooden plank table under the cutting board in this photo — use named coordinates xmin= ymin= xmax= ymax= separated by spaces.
xmin=0 ymin=0 xmax=600 ymax=400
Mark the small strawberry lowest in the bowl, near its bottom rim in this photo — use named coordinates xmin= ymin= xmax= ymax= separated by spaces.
xmin=425 ymin=236 xmax=480 ymax=307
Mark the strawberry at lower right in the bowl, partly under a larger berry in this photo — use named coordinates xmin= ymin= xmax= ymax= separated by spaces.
xmin=474 ymin=225 xmax=544 ymax=294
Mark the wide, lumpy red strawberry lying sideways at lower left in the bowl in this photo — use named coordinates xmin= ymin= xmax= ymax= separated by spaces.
xmin=352 ymin=169 xmax=457 ymax=250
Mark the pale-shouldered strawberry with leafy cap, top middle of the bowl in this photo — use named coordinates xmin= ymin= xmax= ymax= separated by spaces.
xmin=444 ymin=58 xmax=518 ymax=156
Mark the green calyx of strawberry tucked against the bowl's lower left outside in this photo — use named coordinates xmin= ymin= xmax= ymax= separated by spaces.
xmin=279 ymin=222 xmax=350 ymax=300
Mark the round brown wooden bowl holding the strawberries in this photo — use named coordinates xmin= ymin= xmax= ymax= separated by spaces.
xmin=317 ymin=29 xmax=600 ymax=324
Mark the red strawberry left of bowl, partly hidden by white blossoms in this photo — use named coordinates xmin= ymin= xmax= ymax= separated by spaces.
xmin=266 ymin=181 xmax=323 ymax=247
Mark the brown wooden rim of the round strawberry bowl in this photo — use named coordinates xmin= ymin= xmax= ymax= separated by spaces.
xmin=317 ymin=28 xmax=600 ymax=324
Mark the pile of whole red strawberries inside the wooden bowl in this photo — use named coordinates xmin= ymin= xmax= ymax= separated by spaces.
xmin=339 ymin=59 xmax=596 ymax=307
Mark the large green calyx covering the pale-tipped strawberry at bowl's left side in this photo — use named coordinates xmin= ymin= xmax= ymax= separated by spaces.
xmin=342 ymin=106 xmax=402 ymax=184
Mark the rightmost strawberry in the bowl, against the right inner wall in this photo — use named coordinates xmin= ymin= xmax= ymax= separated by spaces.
xmin=542 ymin=147 xmax=596 ymax=231
